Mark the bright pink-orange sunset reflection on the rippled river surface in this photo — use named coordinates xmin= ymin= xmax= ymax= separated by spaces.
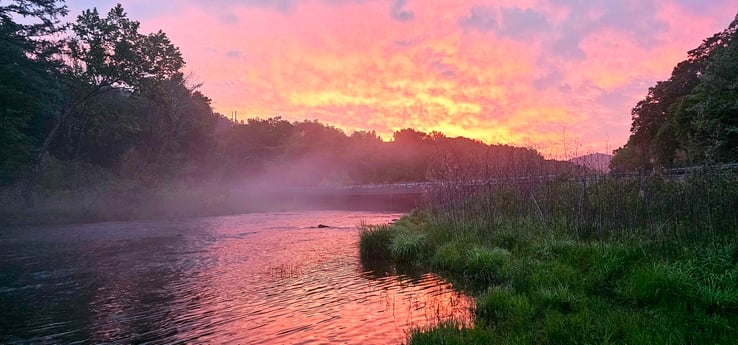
xmin=179 ymin=213 xmax=473 ymax=344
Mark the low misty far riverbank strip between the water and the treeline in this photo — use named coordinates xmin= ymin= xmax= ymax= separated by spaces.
xmin=0 ymin=180 xmax=414 ymax=226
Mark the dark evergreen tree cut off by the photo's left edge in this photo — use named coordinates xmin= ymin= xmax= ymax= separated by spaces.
xmin=0 ymin=0 xmax=67 ymax=184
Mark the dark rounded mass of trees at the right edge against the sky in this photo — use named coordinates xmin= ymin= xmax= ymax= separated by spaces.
xmin=611 ymin=17 xmax=738 ymax=171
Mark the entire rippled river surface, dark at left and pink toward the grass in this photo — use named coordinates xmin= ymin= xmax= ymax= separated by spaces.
xmin=0 ymin=211 xmax=473 ymax=344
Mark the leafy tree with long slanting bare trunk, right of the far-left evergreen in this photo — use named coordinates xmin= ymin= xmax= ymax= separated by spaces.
xmin=23 ymin=4 xmax=184 ymax=206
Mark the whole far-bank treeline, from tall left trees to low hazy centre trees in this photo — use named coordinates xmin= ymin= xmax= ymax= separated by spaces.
xmin=0 ymin=0 xmax=573 ymax=216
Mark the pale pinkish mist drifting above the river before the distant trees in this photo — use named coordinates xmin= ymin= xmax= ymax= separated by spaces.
xmin=139 ymin=154 xmax=424 ymax=219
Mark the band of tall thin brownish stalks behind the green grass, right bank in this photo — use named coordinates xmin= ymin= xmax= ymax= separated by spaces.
xmin=428 ymin=172 xmax=738 ymax=241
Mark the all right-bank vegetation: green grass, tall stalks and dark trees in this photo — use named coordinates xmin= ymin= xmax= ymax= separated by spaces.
xmin=360 ymin=19 xmax=738 ymax=344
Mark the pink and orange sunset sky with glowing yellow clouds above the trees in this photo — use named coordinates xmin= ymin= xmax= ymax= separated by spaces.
xmin=67 ymin=0 xmax=738 ymax=157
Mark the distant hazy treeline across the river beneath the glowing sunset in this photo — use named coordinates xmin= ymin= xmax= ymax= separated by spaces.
xmin=218 ymin=118 xmax=573 ymax=185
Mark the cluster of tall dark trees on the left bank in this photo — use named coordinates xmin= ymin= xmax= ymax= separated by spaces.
xmin=0 ymin=0 xmax=197 ymax=206
